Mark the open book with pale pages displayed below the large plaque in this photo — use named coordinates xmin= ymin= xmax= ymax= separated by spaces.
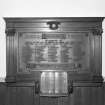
xmin=40 ymin=72 xmax=68 ymax=95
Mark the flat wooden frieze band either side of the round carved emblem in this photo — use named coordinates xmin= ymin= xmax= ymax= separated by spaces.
xmin=7 ymin=21 xmax=101 ymax=28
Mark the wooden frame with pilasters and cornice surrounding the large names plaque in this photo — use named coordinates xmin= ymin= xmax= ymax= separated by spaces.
xmin=4 ymin=17 xmax=104 ymax=81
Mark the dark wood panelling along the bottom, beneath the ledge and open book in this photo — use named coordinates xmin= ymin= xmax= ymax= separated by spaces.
xmin=5 ymin=83 xmax=105 ymax=105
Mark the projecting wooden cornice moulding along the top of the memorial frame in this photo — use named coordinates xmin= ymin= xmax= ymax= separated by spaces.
xmin=4 ymin=17 xmax=104 ymax=25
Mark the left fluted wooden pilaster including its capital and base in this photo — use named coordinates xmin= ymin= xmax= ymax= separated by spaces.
xmin=6 ymin=29 xmax=17 ymax=81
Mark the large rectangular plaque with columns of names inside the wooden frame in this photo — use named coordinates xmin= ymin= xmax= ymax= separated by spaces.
xmin=18 ymin=33 xmax=90 ymax=71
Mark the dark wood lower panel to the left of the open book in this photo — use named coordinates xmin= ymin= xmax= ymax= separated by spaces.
xmin=6 ymin=86 xmax=34 ymax=105
